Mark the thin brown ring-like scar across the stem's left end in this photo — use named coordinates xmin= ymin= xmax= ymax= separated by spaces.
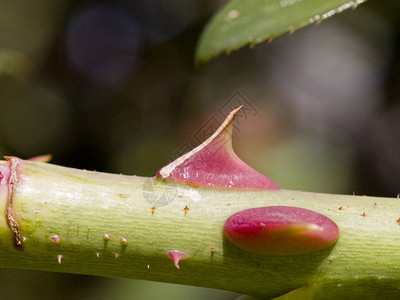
xmin=4 ymin=156 xmax=24 ymax=251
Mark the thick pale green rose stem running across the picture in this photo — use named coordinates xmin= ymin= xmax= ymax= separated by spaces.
xmin=0 ymin=161 xmax=400 ymax=299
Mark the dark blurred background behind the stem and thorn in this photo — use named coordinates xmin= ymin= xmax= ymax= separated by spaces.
xmin=0 ymin=0 xmax=400 ymax=299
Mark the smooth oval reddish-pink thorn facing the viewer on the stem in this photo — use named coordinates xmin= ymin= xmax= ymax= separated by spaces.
xmin=224 ymin=206 xmax=339 ymax=255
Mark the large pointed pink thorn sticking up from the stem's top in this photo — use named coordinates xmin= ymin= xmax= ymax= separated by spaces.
xmin=157 ymin=106 xmax=279 ymax=190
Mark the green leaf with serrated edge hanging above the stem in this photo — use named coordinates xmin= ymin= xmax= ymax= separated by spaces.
xmin=196 ymin=0 xmax=366 ymax=63
